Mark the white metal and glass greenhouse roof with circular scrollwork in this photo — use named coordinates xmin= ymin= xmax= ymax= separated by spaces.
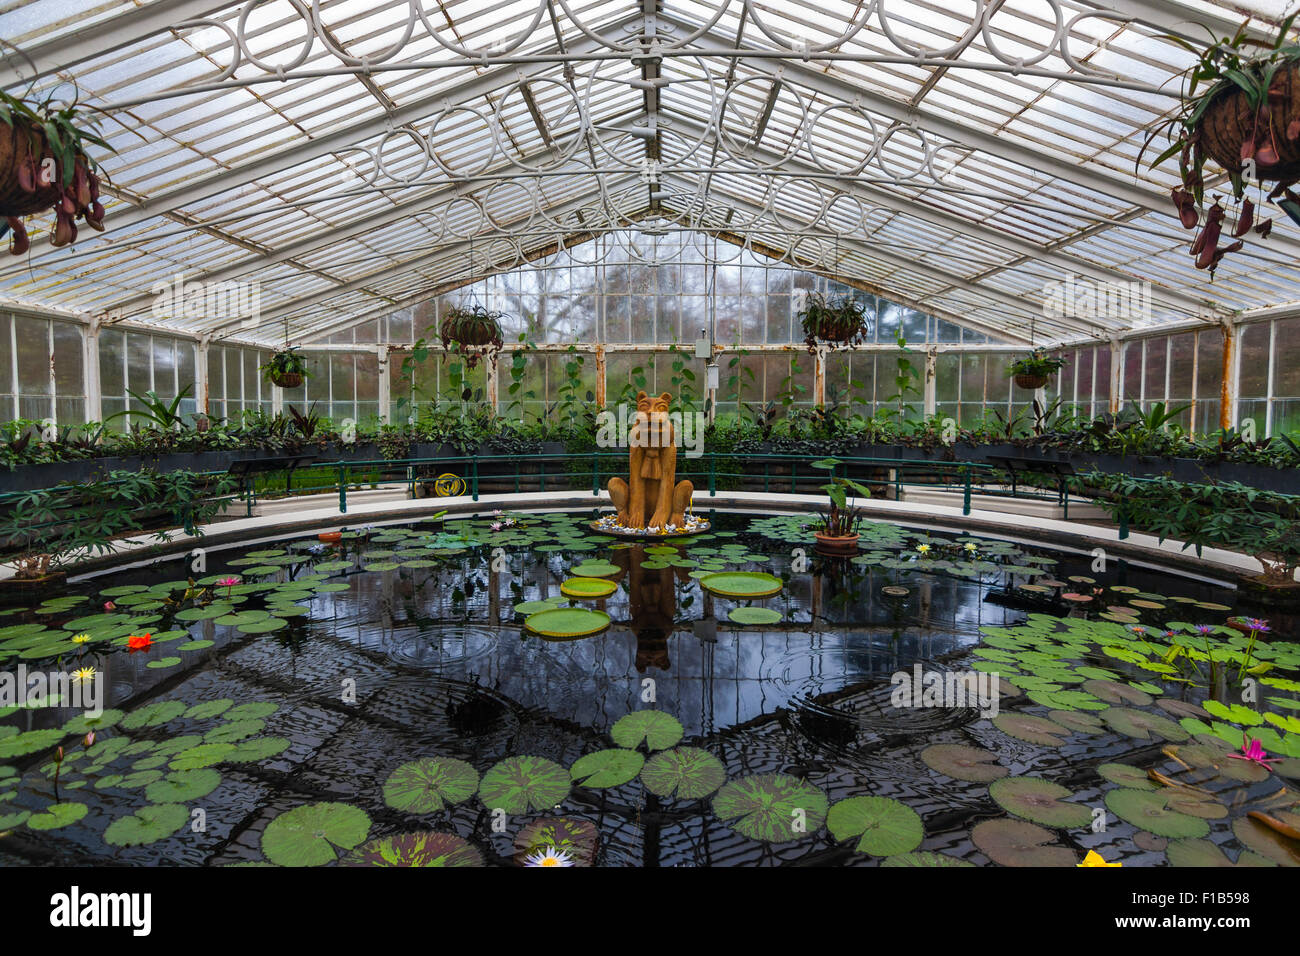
xmin=0 ymin=0 xmax=1300 ymax=345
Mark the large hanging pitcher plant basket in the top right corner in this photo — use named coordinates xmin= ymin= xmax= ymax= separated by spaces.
xmin=1138 ymin=13 xmax=1300 ymax=274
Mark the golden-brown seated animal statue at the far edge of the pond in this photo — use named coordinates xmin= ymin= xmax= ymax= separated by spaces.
xmin=608 ymin=392 xmax=696 ymax=531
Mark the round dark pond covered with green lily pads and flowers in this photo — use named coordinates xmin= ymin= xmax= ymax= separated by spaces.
xmin=0 ymin=511 xmax=1300 ymax=866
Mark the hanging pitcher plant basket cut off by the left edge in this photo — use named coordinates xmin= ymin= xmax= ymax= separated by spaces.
xmin=0 ymin=91 xmax=112 ymax=255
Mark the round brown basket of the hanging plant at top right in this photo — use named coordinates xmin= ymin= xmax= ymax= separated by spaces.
xmin=1200 ymin=62 xmax=1300 ymax=181
